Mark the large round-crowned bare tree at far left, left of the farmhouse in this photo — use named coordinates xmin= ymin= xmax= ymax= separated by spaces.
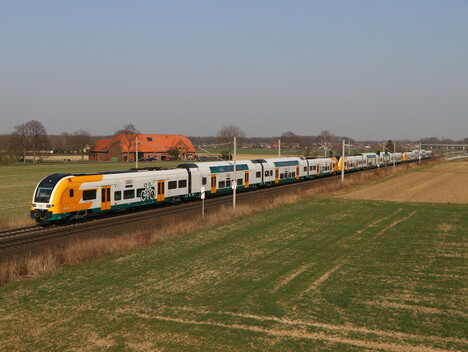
xmin=13 ymin=120 xmax=48 ymax=162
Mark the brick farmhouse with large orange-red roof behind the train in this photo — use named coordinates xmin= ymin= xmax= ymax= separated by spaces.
xmin=89 ymin=134 xmax=195 ymax=161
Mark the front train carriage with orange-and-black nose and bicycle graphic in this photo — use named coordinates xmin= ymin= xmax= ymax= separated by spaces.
xmin=31 ymin=168 xmax=190 ymax=222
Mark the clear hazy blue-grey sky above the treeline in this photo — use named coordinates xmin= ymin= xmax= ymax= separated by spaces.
xmin=0 ymin=0 xmax=468 ymax=139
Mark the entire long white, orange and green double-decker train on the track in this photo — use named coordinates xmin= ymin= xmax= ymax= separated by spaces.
xmin=31 ymin=150 xmax=432 ymax=224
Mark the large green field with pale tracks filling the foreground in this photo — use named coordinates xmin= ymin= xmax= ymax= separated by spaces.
xmin=0 ymin=198 xmax=468 ymax=351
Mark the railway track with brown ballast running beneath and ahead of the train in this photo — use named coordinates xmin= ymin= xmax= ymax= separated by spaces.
xmin=0 ymin=164 xmax=424 ymax=253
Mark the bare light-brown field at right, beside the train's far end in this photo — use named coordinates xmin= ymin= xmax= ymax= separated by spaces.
xmin=338 ymin=160 xmax=468 ymax=204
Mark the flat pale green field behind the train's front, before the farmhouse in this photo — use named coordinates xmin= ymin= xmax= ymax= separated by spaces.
xmin=0 ymin=161 xmax=185 ymax=228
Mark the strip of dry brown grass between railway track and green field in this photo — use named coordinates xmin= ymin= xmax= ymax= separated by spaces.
xmin=0 ymin=164 xmax=424 ymax=285
